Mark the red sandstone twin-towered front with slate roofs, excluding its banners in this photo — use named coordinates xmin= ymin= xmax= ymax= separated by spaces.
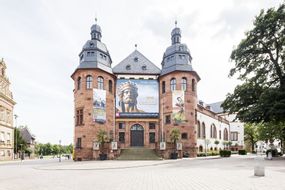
xmin=71 ymin=21 xmax=203 ymax=160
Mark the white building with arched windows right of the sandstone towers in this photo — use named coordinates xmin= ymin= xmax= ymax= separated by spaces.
xmin=197 ymin=101 xmax=244 ymax=152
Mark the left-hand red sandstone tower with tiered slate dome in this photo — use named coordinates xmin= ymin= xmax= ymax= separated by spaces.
xmin=71 ymin=20 xmax=115 ymax=160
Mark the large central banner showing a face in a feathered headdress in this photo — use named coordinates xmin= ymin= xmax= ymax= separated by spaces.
xmin=116 ymin=79 xmax=159 ymax=117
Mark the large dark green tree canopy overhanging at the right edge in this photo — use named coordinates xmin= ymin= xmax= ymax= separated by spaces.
xmin=222 ymin=3 xmax=285 ymax=123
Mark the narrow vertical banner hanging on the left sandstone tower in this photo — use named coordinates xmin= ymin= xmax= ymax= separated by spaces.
xmin=93 ymin=89 xmax=106 ymax=123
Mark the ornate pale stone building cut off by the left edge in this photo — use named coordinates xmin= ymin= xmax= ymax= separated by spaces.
xmin=0 ymin=59 xmax=15 ymax=160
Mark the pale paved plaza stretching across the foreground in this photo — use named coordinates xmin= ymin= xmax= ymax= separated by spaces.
xmin=0 ymin=155 xmax=285 ymax=190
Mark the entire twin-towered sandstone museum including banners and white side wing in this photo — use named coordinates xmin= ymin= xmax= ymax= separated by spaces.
xmin=71 ymin=20 xmax=242 ymax=160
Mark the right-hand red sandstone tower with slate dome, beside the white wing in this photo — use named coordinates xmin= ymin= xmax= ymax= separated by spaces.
xmin=159 ymin=22 xmax=200 ymax=157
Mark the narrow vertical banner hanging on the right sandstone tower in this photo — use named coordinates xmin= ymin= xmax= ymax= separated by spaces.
xmin=172 ymin=90 xmax=186 ymax=124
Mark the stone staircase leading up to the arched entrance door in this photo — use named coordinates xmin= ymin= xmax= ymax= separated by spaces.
xmin=117 ymin=148 xmax=161 ymax=160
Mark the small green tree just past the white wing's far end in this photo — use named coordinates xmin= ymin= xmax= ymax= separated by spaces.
xmin=244 ymin=123 xmax=259 ymax=151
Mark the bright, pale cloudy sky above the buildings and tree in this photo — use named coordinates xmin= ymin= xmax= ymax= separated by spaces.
xmin=0 ymin=0 xmax=284 ymax=144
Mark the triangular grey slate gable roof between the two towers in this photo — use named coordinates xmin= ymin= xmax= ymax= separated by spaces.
xmin=113 ymin=50 xmax=160 ymax=75
